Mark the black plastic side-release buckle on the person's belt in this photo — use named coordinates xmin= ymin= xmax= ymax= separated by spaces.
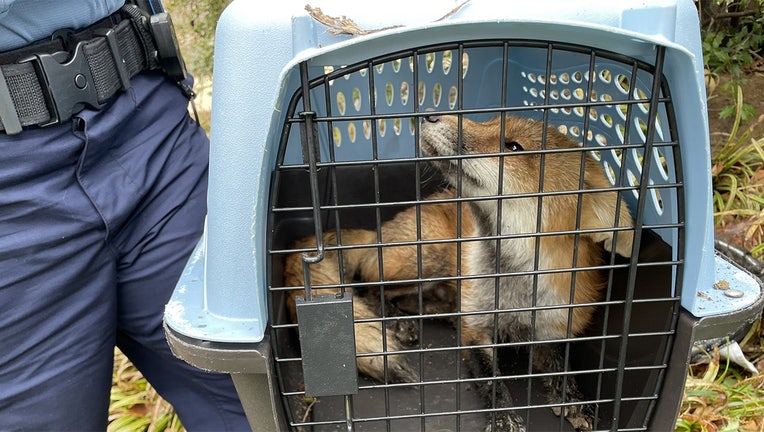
xmin=19 ymin=42 xmax=105 ymax=127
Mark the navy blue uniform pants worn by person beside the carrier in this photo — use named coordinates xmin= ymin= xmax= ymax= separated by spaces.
xmin=0 ymin=73 xmax=249 ymax=431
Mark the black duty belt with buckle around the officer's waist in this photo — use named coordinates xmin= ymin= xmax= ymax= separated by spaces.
xmin=0 ymin=4 xmax=190 ymax=135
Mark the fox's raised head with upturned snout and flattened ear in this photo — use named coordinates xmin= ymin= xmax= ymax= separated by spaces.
xmin=419 ymin=116 xmax=633 ymax=257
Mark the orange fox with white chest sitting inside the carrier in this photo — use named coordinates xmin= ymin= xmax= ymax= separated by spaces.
xmin=284 ymin=114 xmax=634 ymax=432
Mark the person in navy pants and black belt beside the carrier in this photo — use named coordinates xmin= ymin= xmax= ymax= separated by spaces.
xmin=0 ymin=0 xmax=249 ymax=431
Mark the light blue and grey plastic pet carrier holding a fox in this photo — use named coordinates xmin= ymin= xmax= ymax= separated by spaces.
xmin=165 ymin=0 xmax=762 ymax=431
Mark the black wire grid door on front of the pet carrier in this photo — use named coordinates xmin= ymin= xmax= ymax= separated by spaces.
xmin=269 ymin=40 xmax=684 ymax=431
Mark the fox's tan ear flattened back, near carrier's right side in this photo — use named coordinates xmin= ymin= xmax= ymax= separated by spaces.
xmin=581 ymin=192 xmax=634 ymax=258
